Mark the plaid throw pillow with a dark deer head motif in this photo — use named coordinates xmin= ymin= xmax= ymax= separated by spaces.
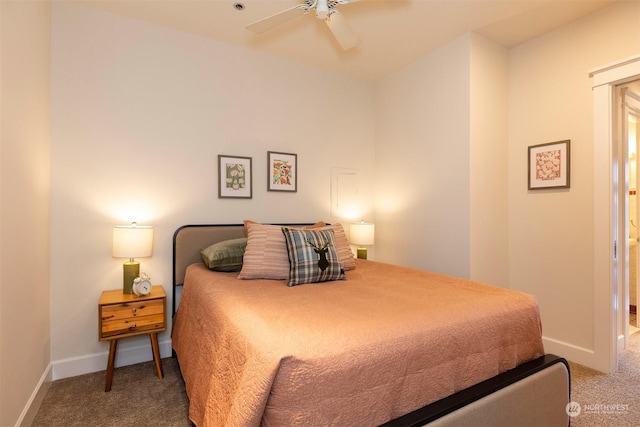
xmin=282 ymin=227 xmax=344 ymax=286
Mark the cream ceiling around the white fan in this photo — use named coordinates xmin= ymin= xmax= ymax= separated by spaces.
xmin=70 ymin=0 xmax=620 ymax=80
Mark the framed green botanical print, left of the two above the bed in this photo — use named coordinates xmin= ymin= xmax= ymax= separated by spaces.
xmin=218 ymin=155 xmax=252 ymax=199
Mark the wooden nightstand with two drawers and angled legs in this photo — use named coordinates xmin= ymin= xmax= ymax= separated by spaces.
xmin=98 ymin=285 xmax=167 ymax=391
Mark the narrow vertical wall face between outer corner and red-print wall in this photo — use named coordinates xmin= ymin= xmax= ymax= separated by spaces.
xmin=469 ymin=35 xmax=509 ymax=287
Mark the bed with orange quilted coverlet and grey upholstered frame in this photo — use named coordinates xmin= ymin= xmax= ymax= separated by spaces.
xmin=172 ymin=222 xmax=570 ymax=427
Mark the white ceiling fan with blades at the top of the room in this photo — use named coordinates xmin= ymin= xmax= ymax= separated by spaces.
xmin=246 ymin=0 xmax=360 ymax=50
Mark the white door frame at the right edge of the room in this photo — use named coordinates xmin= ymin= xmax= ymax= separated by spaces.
xmin=589 ymin=55 xmax=640 ymax=373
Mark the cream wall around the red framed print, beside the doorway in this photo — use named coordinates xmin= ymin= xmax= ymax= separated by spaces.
xmin=509 ymin=1 xmax=640 ymax=364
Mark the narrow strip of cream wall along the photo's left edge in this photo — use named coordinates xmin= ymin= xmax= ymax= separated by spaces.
xmin=0 ymin=1 xmax=51 ymax=426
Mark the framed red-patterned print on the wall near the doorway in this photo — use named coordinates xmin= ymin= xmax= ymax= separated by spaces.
xmin=528 ymin=140 xmax=571 ymax=190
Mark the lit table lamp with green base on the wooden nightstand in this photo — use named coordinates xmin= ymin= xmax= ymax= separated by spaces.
xmin=113 ymin=222 xmax=153 ymax=294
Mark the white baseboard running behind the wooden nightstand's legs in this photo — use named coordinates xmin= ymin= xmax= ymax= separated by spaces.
xmin=52 ymin=339 xmax=171 ymax=381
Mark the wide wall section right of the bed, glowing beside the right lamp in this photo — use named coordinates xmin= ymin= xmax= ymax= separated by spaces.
xmin=376 ymin=36 xmax=470 ymax=277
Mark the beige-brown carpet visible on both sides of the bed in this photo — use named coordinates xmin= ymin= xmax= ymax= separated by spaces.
xmin=33 ymin=333 xmax=640 ymax=427
